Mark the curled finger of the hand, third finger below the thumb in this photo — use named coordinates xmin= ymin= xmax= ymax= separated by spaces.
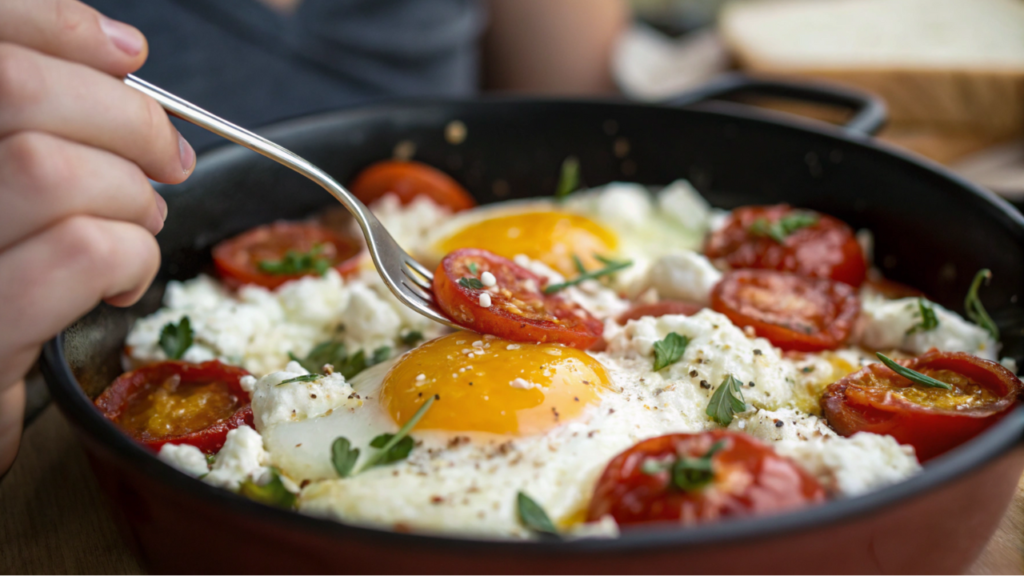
xmin=0 ymin=216 xmax=160 ymax=387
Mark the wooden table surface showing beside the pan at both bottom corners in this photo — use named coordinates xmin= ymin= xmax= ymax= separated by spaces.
xmin=0 ymin=406 xmax=1024 ymax=574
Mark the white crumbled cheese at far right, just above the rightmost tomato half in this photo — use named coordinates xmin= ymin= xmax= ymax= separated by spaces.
xmin=860 ymin=294 xmax=998 ymax=360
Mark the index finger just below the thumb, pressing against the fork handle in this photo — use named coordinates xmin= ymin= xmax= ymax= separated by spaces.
xmin=0 ymin=44 xmax=196 ymax=183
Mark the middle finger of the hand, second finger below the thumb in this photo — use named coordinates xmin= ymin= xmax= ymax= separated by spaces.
xmin=0 ymin=132 xmax=167 ymax=249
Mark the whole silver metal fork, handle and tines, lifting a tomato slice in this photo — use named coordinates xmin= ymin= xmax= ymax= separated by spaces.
xmin=125 ymin=74 xmax=460 ymax=328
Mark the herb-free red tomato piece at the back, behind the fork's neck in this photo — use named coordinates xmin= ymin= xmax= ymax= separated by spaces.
xmin=348 ymin=160 xmax=476 ymax=212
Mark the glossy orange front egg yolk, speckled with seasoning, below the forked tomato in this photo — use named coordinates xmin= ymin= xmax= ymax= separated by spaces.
xmin=381 ymin=332 xmax=608 ymax=436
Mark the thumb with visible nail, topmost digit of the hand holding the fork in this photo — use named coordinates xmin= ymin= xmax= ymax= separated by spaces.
xmin=0 ymin=0 xmax=148 ymax=77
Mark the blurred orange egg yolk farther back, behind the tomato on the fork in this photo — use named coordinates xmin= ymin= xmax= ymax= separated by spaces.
xmin=436 ymin=211 xmax=617 ymax=278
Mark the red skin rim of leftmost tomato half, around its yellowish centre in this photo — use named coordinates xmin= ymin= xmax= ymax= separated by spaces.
xmin=95 ymin=360 xmax=253 ymax=454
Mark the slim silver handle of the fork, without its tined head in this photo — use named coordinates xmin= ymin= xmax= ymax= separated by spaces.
xmin=125 ymin=74 xmax=386 ymax=235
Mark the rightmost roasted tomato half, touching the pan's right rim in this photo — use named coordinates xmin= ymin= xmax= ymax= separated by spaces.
xmin=821 ymin=349 xmax=1022 ymax=461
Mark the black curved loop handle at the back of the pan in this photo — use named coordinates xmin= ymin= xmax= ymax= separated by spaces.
xmin=665 ymin=74 xmax=888 ymax=135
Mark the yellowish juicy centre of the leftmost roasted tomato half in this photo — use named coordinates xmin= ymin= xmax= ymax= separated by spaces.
xmin=118 ymin=375 xmax=240 ymax=439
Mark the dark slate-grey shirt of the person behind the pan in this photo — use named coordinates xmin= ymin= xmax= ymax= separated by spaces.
xmin=86 ymin=0 xmax=485 ymax=150
